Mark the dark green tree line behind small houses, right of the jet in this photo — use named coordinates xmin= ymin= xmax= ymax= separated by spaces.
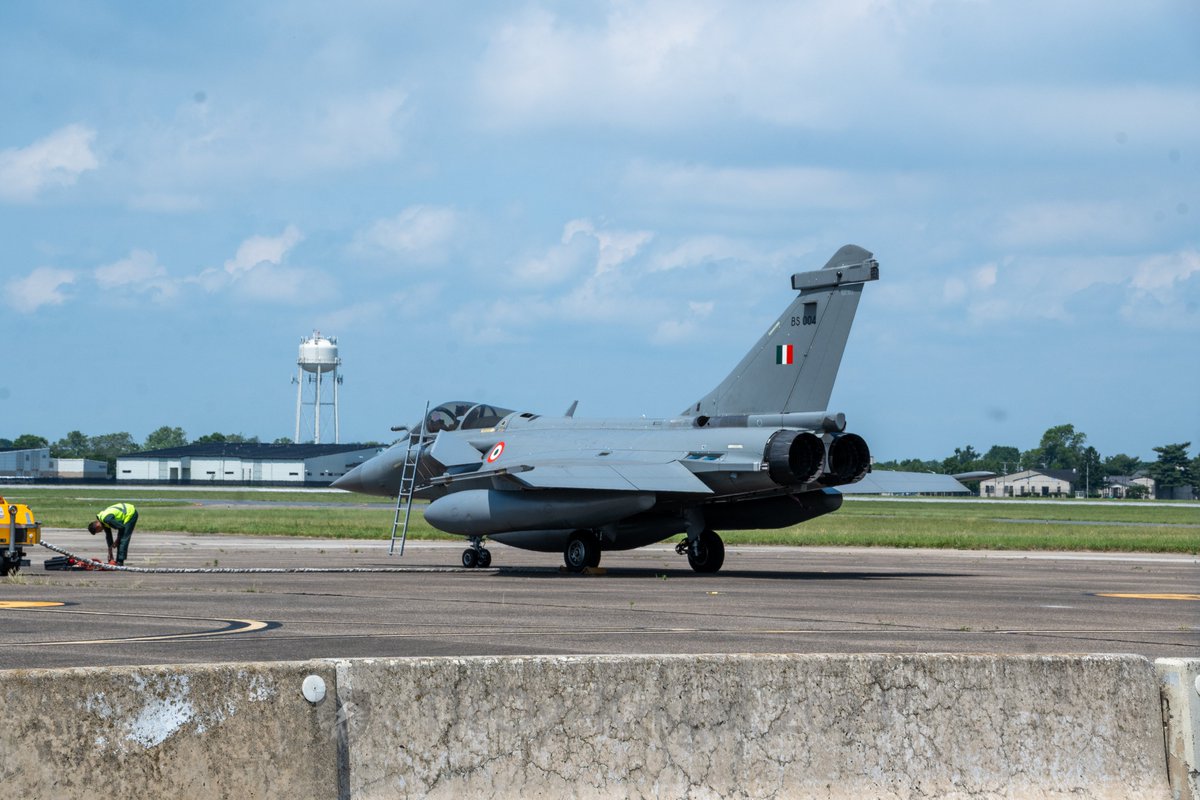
xmin=875 ymin=425 xmax=1200 ymax=497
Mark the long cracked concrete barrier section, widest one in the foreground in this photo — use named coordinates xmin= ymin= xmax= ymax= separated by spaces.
xmin=338 ymin=655 xmax=1168 ymax=800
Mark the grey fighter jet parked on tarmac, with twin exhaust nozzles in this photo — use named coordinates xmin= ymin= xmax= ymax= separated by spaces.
xmin=334 ymin=245 xmax=880 ymax=572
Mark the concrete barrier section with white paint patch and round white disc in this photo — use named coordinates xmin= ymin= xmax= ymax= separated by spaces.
xmin=0 ymin=662 xmax=340 ymax=800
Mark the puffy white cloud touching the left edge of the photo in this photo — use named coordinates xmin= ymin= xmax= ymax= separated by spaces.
xmin=0 ymin=125 xmax=100 ymax=203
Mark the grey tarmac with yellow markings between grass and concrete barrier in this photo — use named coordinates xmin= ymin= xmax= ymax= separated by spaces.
xmin=0 ymin=529 xmax=1200 ymax=669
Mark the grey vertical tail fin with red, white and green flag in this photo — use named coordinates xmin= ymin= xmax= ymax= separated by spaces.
xmin=684 ymin=245 xmax=880 ymax=416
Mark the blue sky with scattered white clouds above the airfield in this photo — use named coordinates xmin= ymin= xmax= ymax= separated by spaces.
xmin=0 ymin=0 xmax=1200 ymax=459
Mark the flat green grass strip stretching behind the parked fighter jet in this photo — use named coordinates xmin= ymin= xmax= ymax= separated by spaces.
xmin=2 ymin=487 xmax=1200 ymax=554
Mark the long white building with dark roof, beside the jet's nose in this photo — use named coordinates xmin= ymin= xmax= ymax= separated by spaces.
xmin=116 ymin=443 xmax=380 ymax=486
